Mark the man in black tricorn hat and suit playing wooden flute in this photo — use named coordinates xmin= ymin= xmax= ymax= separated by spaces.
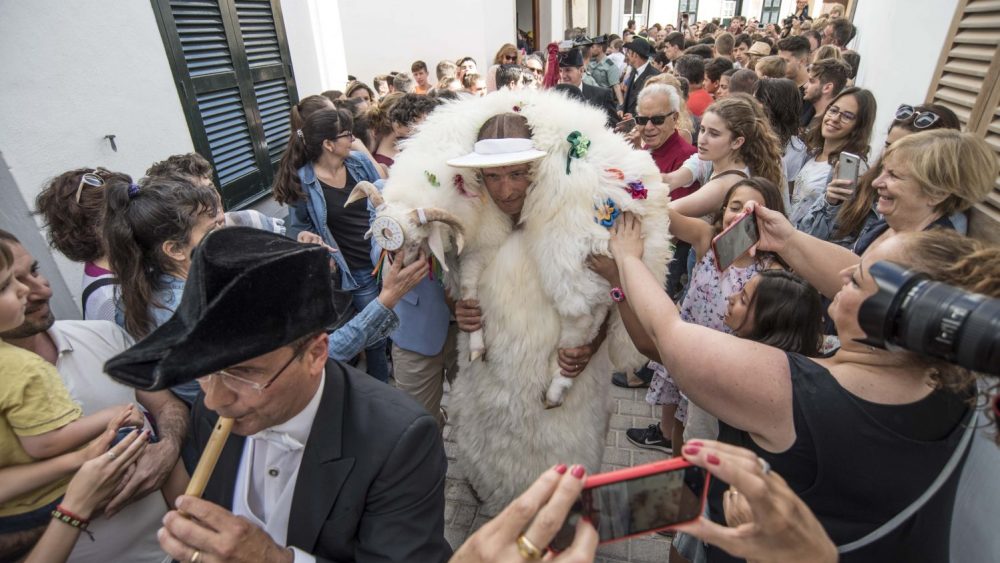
xmin=106 ymin=227 xmax=451 ymax=563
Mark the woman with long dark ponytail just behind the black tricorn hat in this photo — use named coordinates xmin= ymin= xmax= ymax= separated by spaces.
xmin=104 ymin=177 xmax=225 ymax=405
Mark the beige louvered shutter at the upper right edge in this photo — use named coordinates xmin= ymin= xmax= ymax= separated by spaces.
xmin=927 ymin=0 xmax=1000 ymax=243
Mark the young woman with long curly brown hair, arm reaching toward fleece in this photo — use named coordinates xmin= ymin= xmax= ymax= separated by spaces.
xmin=663 ymin=94 xmax=787 ymax=217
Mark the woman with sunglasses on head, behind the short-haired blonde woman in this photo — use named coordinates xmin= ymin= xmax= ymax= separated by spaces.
xmin=797 ymin=104 xmax=971 ymax=248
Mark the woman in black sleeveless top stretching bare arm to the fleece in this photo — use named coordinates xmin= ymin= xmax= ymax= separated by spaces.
xmin=611 ymin=214 xmax=1000 ymax=561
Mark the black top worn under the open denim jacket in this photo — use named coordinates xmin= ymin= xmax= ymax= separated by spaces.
xmin=317 ymin=170 xmax=372 ymax=270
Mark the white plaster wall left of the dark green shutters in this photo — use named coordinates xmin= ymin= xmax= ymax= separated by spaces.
xmin=0 ymin=0 xmax=194 ymax=312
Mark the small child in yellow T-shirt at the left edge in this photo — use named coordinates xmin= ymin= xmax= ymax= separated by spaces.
xmin=0 ymin=244 xmax=144 ymax=540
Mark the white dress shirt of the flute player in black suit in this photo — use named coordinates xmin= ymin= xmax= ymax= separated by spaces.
xmin=233 ymin=371 xmax=326 ymax=563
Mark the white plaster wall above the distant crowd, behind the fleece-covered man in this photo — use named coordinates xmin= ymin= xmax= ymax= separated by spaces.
xmin=338 ymin=0 xmax=516 ymax=85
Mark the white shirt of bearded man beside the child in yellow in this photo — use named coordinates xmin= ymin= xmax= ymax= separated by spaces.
xmin=48 ymin=321 xmax=167 ymax=563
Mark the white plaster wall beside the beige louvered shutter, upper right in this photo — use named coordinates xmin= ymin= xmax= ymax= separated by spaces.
xmin=852 ymin=0 xmax=958 ymax=158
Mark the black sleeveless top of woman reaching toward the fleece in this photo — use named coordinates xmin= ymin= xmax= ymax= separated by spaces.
xmin=708 ymin=354 xmax=969 ymax=563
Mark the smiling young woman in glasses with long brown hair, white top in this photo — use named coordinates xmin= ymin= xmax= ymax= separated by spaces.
xmin=788 ymin=88 xmax=876 ymax=227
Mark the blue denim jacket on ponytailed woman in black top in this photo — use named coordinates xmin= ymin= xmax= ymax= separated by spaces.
xmin=288 ymin=151 xmax=380 ymax=291
